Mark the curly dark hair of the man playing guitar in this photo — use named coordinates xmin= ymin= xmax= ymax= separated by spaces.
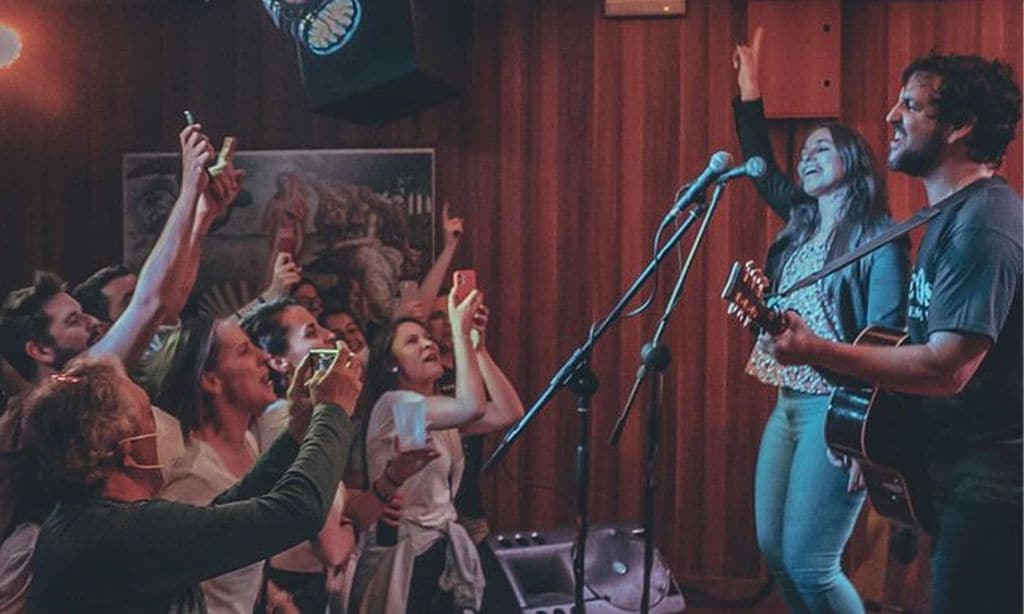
xmin=902 ymin=51 xmax=1021 ymax=168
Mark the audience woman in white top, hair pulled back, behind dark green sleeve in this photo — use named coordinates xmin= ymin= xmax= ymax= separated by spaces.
xmin=142 ymin=318 xmax=355 ymax=614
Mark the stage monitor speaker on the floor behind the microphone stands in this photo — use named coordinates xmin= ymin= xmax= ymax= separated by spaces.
xmin=487 ymin=524 xmax=686 ymax=614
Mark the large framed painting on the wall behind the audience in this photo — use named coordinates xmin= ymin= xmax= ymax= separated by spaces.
xmin=123 ymin=148 xmax=435 ymax=324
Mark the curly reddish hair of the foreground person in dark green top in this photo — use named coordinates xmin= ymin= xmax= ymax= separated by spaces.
xmin=22 ymin=357 xmax=138 ymax=500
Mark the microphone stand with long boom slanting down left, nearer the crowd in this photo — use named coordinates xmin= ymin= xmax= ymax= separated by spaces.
xmin=482 ymin=189 xmax=705 ymax=614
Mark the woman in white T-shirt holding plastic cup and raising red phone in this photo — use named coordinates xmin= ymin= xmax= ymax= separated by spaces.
xmin=349 ymin=288 xmax=523 ymax=612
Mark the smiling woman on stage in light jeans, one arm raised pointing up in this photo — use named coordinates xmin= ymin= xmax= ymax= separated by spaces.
xmin=733 ymin=28 xmax=907 ymax=614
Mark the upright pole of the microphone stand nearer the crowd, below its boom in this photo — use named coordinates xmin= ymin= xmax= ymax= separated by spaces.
xmin=568 ymin=357 xmax=597 ymax=614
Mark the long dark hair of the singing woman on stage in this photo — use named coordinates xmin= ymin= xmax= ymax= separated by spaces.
xmin=776 ymin=122 xmax=889 ymax=265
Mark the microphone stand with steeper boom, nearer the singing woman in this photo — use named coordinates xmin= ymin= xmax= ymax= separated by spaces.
xmin=610 ymin=183 xmax=725 ymax=614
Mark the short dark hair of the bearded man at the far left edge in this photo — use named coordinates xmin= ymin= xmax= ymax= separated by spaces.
xmin=0 ymin=271 xmax=67 ymax=381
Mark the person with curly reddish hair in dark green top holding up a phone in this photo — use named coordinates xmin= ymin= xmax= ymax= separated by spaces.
xmin=23 ymin=358 xmax=359 ymax=614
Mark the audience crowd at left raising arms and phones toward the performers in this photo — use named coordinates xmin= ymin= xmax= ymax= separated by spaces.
xmin=0 ymin=125 xmax=522 ymax=614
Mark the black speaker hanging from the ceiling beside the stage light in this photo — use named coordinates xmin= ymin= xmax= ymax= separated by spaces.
xmin=298 ymin=0 xmax=472 ymax=125
